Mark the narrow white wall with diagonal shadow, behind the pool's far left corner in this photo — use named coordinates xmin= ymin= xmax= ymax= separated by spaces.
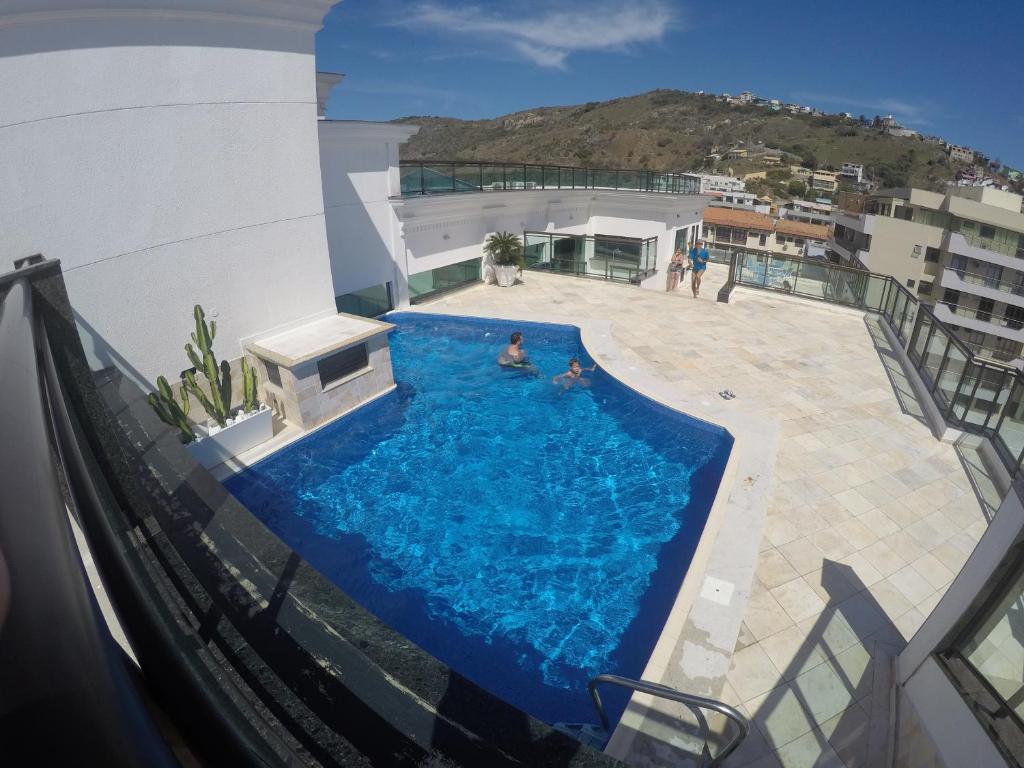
xmin=319 ymin=120 xmax=419 ymax=305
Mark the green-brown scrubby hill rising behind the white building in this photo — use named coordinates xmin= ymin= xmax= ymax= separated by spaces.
xmin=395 ymin=90 xmax=955 ymax=189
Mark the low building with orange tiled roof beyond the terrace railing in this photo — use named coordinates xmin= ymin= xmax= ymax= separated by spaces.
xmin=703 ymin=207 xmax=828 ymax=256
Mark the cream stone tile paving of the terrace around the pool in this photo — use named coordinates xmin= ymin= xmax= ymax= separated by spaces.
xmin=417 ymin=265 xmax=998 ymax=768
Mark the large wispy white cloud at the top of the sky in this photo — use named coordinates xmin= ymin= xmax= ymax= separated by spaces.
xmin=392 ymin=0 xmax=675 ymax=69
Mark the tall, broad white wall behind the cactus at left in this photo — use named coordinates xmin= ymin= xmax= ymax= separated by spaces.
xmin=0 ymin=0 xmax=334 ymax=382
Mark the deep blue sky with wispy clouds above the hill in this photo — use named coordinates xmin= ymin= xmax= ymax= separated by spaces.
xmin=316 ymin=0 xmax=1024 ymax=168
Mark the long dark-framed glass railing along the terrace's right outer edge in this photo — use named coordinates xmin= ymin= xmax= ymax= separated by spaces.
xmin=729 ymin=253 xmax=1024 ymax=475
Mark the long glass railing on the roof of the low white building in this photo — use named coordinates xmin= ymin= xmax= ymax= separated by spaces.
xmin=398 ymin=160 xmax=700 ymax=197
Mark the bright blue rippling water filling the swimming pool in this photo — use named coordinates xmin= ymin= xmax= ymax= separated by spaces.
xmin=226 ymin=313 xmax=732 ymax=723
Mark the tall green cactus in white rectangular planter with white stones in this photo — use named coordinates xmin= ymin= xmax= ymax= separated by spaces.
xmin=148 ymin=304 xmax=273 ymax=467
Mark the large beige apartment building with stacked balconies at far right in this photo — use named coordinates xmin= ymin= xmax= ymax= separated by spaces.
xmin=828 ymin=186 xmax=1024 ymax=364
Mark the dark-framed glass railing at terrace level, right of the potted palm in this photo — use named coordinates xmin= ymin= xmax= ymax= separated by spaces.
xmin=523 ymin=231 xmax=657 ymax=284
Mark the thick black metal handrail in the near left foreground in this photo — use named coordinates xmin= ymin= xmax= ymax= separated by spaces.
xmin=0 ymin=268 xmax=175 ymax=766
